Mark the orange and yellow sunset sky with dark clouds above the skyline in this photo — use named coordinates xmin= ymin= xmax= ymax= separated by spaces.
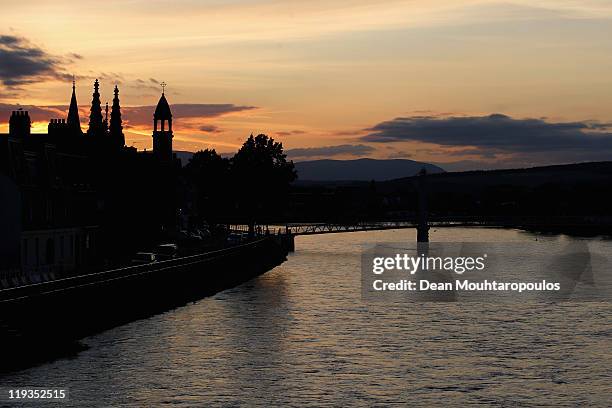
xmin=0 ymin=0 xmax=612 ymax=169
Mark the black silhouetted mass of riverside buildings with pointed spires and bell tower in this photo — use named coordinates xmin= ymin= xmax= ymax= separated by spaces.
xmin=0 ymin=80 xmax=180 ymax=286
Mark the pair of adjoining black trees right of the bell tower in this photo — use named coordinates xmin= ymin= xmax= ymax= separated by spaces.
xmin=182 ymin=134 xmax=297 ymax=236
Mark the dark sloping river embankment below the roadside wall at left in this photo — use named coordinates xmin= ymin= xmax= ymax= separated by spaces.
xmin=0 ymin=236 xmax=287 ymax=376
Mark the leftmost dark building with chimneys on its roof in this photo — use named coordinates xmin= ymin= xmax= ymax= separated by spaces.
xmin=0 ymin=103 xmax=97 ymax=286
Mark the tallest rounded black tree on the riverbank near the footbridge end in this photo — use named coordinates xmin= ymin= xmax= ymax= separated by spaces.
xmin=231 ymin=134 xmax=297 ymax=234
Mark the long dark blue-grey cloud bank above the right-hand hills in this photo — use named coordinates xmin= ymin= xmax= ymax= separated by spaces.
xmin=360 ymin=114 xmax=612 ymax=167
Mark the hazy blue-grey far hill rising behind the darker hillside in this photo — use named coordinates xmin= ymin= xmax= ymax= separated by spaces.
xmin=295 ymin=159 xmax=444 ymax=181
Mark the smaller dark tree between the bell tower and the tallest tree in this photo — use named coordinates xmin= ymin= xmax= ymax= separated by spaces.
xmin=184 ymin=149 xmax=232 ymax=227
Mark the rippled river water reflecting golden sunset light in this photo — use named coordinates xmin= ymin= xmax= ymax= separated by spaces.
xmin=2 ymin=228 xmax=612 ymax=407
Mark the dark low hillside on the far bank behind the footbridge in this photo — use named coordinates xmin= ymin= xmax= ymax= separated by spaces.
xmin=287 ymin=162 xmax=612 ymax=223
